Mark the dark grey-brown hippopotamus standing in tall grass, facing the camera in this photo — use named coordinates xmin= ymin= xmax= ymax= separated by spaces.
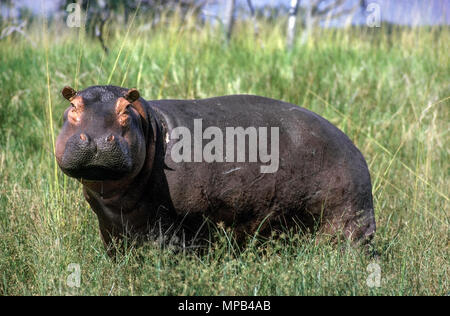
xmin=55 ymin=86 xmax=376 ymax=253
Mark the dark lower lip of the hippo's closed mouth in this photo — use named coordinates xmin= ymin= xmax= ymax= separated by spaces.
xmin=63 ymin=166 xmax=130 ymax=181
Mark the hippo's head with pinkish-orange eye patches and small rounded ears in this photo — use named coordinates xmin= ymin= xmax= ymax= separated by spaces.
xmin=55 ymin=86 xmax=149 ymax=181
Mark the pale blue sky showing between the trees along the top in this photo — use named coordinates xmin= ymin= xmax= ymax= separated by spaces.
xmin=2 ymin=0 xmax=450 ymax=25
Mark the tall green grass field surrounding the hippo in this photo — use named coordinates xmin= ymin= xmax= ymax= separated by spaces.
xmin=0 ymin=13 xmax=450 ymax=295
